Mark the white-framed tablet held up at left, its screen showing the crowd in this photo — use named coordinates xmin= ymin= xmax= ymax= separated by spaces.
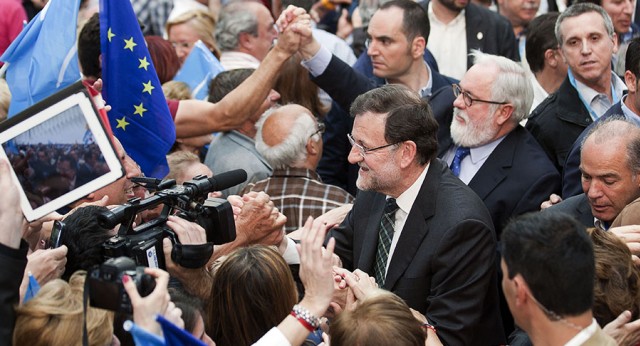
xmin=0 ymin=82 xmax=124 ymax=221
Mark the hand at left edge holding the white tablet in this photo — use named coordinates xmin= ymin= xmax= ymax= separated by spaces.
xmin=0 ymin=160 xmax=24 ymax=249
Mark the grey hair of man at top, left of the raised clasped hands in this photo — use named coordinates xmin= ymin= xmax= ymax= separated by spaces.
xmin=216 ymin=2 xmax=258 ymax=51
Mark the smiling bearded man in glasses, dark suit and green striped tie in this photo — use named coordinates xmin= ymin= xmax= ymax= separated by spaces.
xmin=329 ymin=85 xmax=505 ymax=345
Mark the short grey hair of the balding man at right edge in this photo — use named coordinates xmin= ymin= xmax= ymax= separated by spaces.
xmin=580 ymin=114 xmax=640 ymax=174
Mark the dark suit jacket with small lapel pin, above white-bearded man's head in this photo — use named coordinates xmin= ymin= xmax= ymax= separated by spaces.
xmin=421 ymin=1 xmax=518 ymax=69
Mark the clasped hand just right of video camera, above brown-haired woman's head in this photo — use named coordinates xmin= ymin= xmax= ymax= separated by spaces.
xmin=236 ymin=192 xmax=287 ymax=246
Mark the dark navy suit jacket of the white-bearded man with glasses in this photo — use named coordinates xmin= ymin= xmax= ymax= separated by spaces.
xmin=441 ymin=126 xmax=560 ymax=239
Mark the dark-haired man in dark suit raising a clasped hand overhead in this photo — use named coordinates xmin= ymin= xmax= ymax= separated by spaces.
xmin=292 ymin=0 xmax=453 ymax=194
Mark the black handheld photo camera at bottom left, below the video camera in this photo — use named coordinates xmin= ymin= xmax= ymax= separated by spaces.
xmin=87 ymin=257 xmax=156 ymax=314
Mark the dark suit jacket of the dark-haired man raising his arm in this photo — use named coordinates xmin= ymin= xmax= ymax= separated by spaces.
xmin=313 ymin=56 xmax=456 ymax=196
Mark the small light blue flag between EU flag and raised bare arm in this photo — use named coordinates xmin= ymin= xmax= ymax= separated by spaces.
xmin=173 ymin=41 xmax=224 ymax=100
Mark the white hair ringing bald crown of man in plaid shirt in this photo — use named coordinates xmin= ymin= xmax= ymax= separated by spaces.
xmin=256 ymin=109 xmax=322 ymax=169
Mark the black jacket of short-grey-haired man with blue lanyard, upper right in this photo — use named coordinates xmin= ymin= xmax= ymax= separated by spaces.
xmin=526 ymin=77 xmax=593 ymax=173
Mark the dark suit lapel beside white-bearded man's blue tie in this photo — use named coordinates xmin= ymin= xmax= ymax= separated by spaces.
xmin=469 ymin=125 xmax=524 ymax=200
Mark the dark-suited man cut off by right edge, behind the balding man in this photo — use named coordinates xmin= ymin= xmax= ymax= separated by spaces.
xmin=562 ymin=37 xmax=640 ymax=198
